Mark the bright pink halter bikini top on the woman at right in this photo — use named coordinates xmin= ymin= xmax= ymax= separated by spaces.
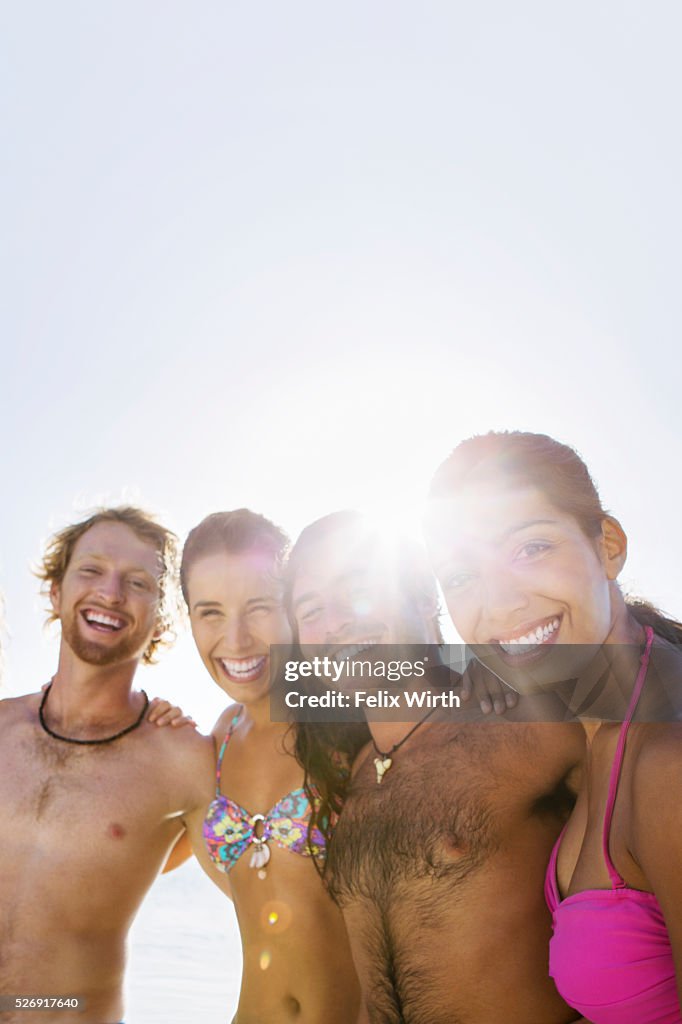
xmin=545 ymin=627 xmax=682 ymax=1024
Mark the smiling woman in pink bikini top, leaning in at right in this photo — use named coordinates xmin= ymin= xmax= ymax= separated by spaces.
xmin=428 ymin=432 xmax=682 ymax=1024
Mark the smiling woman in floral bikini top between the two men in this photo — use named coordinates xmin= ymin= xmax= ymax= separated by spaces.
xmin=165 ymin=509 xmax=366 ymax=1024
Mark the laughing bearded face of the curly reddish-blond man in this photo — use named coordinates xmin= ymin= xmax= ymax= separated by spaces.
xmin=50 ymin=521 xmax=162 ymax=667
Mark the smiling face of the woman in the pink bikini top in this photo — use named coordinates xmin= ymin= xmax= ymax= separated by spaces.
xmin=428 ymin=481 xmax=625 ymax=691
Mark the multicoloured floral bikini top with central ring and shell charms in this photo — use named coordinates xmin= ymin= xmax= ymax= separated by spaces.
xmin=204 ymin=708 xmax=327 ymax=879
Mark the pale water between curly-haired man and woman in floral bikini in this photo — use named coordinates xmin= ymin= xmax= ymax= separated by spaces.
xmin=125 ymin=858 xmax=242 ymax=1024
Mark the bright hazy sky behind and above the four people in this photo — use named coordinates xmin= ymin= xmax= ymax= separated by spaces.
xmin=0 ymin=0 xmax=682 ymax=725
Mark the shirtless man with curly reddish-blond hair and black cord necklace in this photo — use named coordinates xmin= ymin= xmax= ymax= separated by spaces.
xmin=0 ymin=508 xmax=214 ymax=1024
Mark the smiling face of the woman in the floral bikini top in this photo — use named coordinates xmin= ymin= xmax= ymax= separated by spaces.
xmin=187 ymin=548 xmax=292 ymax=705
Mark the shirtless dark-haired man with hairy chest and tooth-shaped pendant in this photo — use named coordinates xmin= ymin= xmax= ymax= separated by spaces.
xmin=289 ymin=513 xmax=583 ymax=1024
